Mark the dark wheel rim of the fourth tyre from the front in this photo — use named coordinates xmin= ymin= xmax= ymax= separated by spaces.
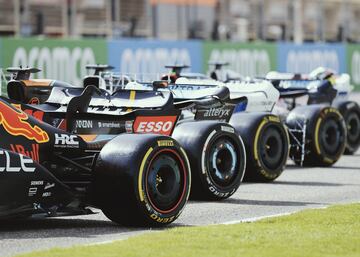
xmin=320 ymin=118 xmax=342 ymax=155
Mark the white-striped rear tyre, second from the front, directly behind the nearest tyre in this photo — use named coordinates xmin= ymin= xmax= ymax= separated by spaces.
xmin=173 ymin=121 xmax=246 ymax=200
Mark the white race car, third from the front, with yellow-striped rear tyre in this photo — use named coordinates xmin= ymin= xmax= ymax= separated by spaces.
xmin=106 ymin=66 xmax=289 ymax=181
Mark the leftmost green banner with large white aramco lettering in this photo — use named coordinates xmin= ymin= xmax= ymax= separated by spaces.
xmin=1 ymin=38 xmax=107 ymax=85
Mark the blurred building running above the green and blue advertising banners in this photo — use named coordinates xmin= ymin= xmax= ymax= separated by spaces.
xmin=0 ymin=0 xmax=360 ymax=42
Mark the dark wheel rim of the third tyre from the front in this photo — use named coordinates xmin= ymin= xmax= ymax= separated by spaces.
xmin=260 ymin=126 xmax=285 ymax=170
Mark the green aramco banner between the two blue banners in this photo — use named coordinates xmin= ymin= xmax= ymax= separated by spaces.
xmin=203 ymin=42 xmax=277 ymax=77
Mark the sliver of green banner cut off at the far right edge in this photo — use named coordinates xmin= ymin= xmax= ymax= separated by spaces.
xmin=346 ymin=44 xmax=360 ymax=91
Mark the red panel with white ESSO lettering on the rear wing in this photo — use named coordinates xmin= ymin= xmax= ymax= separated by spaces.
xmin=134 ymin=116 xmax=177 ymax=136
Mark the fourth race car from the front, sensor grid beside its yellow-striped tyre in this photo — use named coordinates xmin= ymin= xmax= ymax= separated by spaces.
xmin=202 ymin=62 xmax=346 ymax=166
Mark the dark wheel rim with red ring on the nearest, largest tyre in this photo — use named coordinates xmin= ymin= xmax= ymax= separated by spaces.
xmin=145 ymin=150 xmax=186 ymax=213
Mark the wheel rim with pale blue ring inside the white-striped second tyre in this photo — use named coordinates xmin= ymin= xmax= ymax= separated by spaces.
xmin=208 ymin=138 xmax=239 ymax=187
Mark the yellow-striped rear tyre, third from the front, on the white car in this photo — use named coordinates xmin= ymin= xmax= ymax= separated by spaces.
xmin=230 ymin=113 xmax=289 ymax=182
